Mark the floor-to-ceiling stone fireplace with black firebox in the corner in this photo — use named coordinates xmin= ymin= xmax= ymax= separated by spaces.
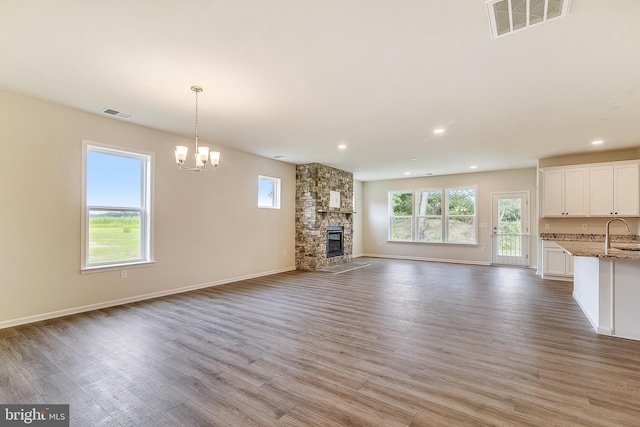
xmin=296 ymin=163 xmax=353 ymax=270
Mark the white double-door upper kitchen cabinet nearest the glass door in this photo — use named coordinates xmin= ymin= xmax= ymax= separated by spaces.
xmin=542 ymin=168 xmax=589 ymax=217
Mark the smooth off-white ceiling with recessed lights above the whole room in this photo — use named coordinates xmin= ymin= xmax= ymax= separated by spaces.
xmin=0 ymin=0 xmax=640 ymax=181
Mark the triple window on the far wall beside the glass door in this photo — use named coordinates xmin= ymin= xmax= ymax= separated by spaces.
xmin=389 ymin=187 xmax=477 ymax=244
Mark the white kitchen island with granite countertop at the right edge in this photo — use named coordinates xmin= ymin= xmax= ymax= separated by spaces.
xmin=556 ymin=241 xmax=640 ymax=340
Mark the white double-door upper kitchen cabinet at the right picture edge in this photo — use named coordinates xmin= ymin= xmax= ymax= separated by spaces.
xmin=589 ymin=163 xmax=640 ymax=216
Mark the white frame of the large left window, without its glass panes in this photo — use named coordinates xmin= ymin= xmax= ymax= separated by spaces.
xmin=81 ymin=140 xmax=154 ymax=272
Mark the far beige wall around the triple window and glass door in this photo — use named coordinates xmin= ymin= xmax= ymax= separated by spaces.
xmin=362 ymin=168 xmax=538 ymax=266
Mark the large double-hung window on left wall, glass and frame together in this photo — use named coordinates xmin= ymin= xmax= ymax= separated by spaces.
xmin=83 ymin=143 xmax=151 ymax=268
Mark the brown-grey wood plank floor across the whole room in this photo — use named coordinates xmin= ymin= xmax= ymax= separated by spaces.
xmin=0 ymin=259 xmax=640 ymax=427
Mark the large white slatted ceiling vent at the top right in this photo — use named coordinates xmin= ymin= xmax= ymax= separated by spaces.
xmin=487 ymin=0 xmax=571 ymax=38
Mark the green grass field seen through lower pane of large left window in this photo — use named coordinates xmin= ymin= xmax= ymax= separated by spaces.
xmin=89 ymin=215 xmax=140 ymax=264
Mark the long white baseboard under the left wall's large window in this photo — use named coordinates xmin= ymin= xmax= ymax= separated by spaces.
xmin=0 ymin=267 xmax=296 ymax=329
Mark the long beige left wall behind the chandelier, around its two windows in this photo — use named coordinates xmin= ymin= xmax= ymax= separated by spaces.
xmin=0 ymin=91 xmax=295 ymax=327
